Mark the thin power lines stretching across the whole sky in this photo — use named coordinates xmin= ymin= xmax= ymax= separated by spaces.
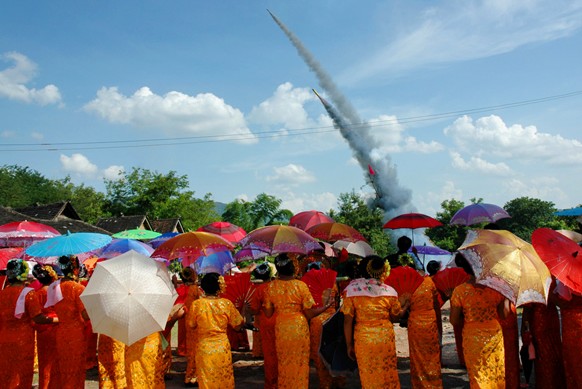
xmin=0 ymin=90 xmax=582 ymax=152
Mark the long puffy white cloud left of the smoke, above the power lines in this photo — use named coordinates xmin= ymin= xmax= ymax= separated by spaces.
xmin=84 ymin=87 xmax=256 ymax=143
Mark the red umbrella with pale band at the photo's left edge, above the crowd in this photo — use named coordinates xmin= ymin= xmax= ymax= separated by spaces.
xmin=0 ymin=220 xmax=61 ymax=247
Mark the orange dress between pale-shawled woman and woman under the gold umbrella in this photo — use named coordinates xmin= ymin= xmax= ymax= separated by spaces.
xmin=408 ymin=277 xmax=443 ymax=388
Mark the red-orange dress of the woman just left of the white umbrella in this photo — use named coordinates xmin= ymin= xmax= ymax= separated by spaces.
xmin=51 ymin=279 xmax=87 ymax=389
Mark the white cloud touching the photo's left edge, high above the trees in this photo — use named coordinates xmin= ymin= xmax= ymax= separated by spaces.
xmin=0 ymin=52 xmax=61 ymax=105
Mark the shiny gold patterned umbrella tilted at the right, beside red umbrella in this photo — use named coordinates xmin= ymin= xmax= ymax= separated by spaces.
xmin=459 ymin=229 xmax=552 ymax=306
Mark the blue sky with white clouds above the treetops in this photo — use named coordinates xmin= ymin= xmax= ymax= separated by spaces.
xmin=0 ymin=0 xmax=582 ymax=218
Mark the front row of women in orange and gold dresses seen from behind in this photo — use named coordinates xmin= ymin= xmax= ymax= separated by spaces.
xmin=0 ymin=232 xmax=582 ymax=389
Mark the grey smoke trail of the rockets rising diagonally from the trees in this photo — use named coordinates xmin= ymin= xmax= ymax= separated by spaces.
xmin=267 ymin=10 xmax=412 ymax=215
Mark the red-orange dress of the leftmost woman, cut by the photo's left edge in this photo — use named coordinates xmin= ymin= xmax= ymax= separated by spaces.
xmin=0 ymin=285 xmax=39 ymax=389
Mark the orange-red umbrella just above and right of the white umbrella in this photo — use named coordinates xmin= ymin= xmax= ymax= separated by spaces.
xmin=151 ymin=231 xmax=234 ymax=266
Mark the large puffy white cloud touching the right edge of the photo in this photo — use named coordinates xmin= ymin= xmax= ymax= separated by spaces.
xmin=444 ymin=115 xmax=582 ymax=165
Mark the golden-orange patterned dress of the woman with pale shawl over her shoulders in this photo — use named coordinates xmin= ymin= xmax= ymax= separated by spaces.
xmin=341 ymin=296 xmax=402 ymax=389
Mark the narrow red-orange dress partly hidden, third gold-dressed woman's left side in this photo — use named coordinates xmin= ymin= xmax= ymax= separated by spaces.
xmin=251 ymin=283 xmax=278 ymax=389
